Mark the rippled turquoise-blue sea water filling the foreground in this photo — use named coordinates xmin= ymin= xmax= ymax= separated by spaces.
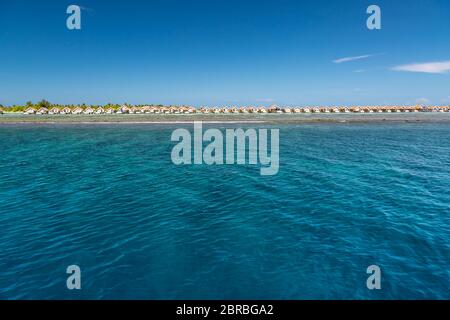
xmin=0 ymin=123 xmax=450 ymax=299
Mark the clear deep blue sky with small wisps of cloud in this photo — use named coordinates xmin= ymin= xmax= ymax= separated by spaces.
xmin=0 ymin=0 xmax=450 ymax=106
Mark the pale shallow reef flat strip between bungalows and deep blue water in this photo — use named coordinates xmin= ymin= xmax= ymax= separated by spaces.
xmin=0 ymin=112 xmax=450 ymax=125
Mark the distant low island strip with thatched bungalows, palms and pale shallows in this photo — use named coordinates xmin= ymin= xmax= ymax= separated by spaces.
xmin=0 ymin=100 xmax=450 ymax=125
